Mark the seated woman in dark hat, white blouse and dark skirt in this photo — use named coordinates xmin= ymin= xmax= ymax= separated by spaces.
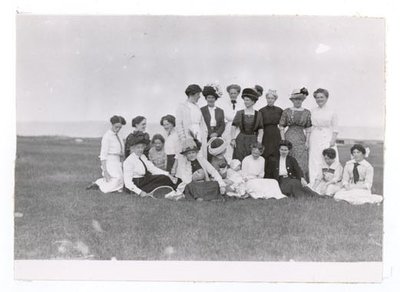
xmin=124 ymin=131 xmax=177 ymax=197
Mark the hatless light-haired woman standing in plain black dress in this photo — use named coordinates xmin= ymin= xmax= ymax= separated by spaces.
xmin=260 ymin=89 xmax=282 ymax=175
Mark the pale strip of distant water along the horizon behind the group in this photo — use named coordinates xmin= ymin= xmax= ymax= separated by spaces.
xmin=17 ymin=121 xmax=384 ymax=141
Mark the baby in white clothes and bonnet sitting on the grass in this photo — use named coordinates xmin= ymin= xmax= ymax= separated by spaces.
xmin=225 ymin=159 xmax=248 ymax=198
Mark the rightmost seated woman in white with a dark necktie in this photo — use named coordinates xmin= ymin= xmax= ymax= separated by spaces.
xmin=334 ymin=144 xmax=383 ymax=205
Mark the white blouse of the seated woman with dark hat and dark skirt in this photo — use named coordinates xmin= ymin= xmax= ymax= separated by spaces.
xmin=123 ymin=153 xmax=168 ymax=195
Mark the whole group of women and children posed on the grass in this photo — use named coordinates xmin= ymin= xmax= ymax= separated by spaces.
xmin=88 ymin=84 xmax=382 ymax=204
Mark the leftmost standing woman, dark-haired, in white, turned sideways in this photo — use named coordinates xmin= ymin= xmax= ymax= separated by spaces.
xmin=176 ymin=84 xmax=208 ymax=157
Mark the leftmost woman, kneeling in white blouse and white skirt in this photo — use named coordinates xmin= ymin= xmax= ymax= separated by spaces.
xmin=87 ymin=116 xmax=126 ymax=193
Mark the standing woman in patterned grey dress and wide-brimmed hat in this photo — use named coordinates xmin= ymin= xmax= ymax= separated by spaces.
xmin=279 ymin=87 xmax=312 ymax=180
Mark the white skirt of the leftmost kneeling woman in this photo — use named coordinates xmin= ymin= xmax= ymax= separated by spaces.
xmin=95 ymin=155 xmax=124 ymax=193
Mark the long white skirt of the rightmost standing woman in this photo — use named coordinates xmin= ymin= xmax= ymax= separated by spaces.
xmin=308 ymin=127 xmax=339 ymax=184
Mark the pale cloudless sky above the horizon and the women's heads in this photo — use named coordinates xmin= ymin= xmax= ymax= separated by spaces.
xmin=16 ymin=15 xmax=385 ymax=127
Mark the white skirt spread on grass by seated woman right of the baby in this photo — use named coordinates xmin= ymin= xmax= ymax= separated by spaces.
xmin=246 ymin=178 xmax=286 ymax=199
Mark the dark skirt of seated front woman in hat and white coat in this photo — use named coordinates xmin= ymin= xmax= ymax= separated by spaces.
xmin=184 ymin=181 xmax=222 ymax=201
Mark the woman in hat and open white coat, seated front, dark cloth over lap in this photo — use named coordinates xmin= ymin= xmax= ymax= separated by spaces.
xmin=174 ymin=138 xmax=225 ymax=201
